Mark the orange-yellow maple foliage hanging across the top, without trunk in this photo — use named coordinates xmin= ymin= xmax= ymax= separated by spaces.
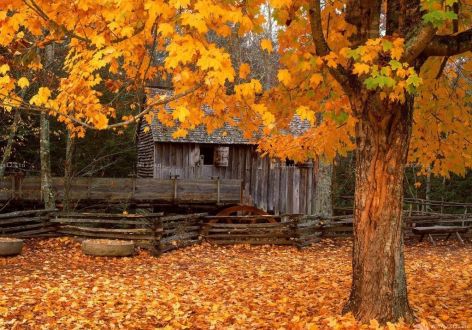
xmin=0 ymin=0 xmax=472 ymax=175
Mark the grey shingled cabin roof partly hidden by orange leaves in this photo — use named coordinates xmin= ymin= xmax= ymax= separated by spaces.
xmin=147 ymin=88 xmax=310 ymax=144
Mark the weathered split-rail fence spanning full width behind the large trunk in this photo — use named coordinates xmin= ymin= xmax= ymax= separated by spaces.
xmin=0 ymin=210 xmax=472 ymax=254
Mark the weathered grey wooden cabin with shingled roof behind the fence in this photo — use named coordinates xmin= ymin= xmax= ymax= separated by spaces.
xmin=137 ymin=90 xmax=316 ymax=214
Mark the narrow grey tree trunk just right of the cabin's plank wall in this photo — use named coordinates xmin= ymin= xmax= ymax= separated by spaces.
xmin=314 ymin=160 xmax=333 ymax=217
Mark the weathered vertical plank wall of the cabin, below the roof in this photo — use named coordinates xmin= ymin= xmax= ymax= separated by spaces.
xmin=153 ymin=142 xmax=316 ymax=214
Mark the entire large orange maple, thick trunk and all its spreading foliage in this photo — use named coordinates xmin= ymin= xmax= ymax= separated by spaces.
xmin=0 ymin=0 xmax=472 ymax=322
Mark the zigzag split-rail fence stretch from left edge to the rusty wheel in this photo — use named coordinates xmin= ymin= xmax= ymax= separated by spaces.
xmin=0 ymin=210 xmax=207 ymax=254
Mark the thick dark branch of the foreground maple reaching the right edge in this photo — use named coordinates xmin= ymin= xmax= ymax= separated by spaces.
xmin=423 ymin=29 xmax=472 ymax=56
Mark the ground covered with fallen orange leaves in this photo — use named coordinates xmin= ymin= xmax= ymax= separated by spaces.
xmin=0 ymin=238 xmax=472 ymax=329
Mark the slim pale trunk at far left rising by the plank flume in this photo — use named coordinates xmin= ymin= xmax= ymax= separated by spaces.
xmin=39 ymin=112 xmax=56 ymax=209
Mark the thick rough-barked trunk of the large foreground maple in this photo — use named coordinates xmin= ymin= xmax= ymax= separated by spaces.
xmin=344 ymin=94 xmax=413 ymax=323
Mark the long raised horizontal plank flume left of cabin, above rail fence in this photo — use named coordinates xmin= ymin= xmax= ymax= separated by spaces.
xmin=0 ymin=177 xmax=241 ymax=204
